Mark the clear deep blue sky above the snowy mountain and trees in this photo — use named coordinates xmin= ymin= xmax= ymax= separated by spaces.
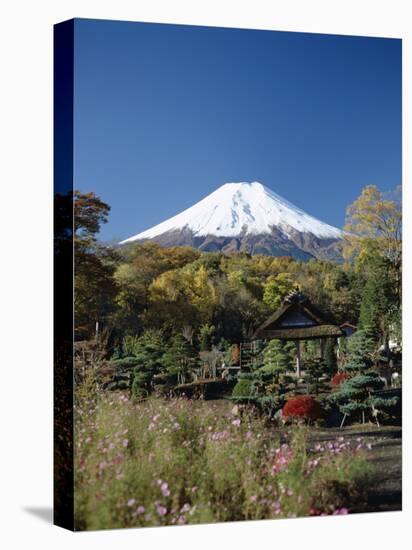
xmin=75 ymin=19 xmax=402 ymax=240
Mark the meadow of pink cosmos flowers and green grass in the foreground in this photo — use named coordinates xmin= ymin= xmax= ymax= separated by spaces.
xmin=71 ymin=393 xmax=384 ymax=529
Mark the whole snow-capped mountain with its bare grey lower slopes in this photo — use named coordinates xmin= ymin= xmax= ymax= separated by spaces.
xmin=120 ymin=181 xmax=343 ymax=260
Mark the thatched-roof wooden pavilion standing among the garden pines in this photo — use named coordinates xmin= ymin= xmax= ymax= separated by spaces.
xmin=253 ymin=290 xmax=345 ymax=376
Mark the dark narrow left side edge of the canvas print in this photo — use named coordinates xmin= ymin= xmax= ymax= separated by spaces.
xmin=53 ymin=20 xmax=74 ymax=530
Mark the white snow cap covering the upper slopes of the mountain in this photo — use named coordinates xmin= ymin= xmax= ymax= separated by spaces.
xmin=120 ymin=181 xmax=343 ymax=244
